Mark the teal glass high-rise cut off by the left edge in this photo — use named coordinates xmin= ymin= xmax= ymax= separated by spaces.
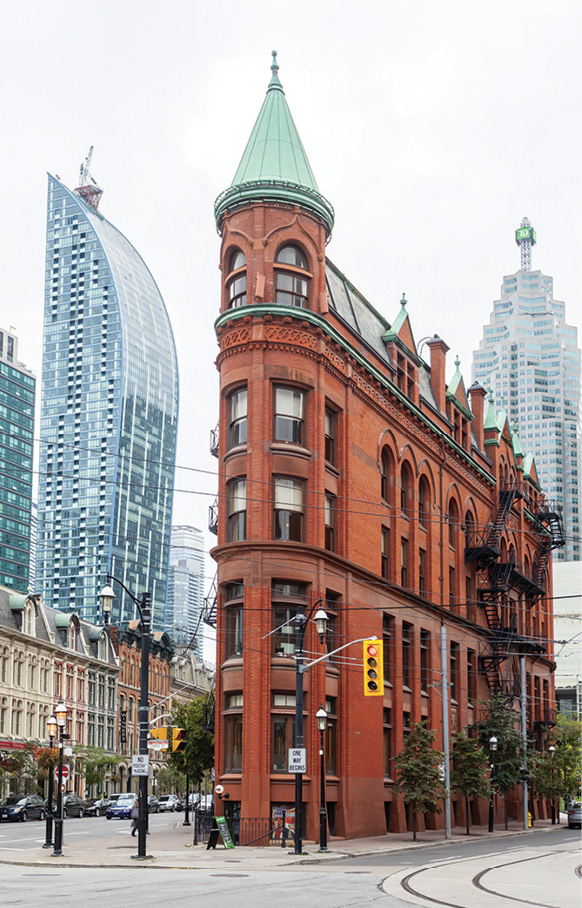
xmin=0 ymin=328 xmax=36 ymax=592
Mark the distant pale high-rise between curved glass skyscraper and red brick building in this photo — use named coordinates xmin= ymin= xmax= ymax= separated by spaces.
xmin=166 ymin=526 xmax=204 ymax=661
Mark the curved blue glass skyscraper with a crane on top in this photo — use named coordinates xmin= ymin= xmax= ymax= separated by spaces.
xmin=37 ymin=166 xmax=178 ymax=630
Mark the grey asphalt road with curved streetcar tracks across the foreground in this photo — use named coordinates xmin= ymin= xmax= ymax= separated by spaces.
xmin=0 ymin=828 xmax=580 ymax=908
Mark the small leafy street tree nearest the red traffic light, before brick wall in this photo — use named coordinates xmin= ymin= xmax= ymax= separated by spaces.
xmin=394 ymin=720 xmax=445 ymax=841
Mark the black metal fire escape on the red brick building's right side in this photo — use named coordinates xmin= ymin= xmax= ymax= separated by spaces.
xmin=465 ymin=480 xmax=564 ymax=695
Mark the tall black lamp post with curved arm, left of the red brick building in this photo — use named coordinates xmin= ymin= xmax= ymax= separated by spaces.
xmin=100 ymin=574 xmax=152 ymax=860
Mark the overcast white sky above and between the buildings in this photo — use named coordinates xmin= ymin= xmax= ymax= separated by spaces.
xmin=0 ymin=0 xmax=582 ymax=624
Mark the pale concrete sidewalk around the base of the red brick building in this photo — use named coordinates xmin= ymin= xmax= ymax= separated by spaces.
xmin=0 ymin=820 xmax=567 ymax=870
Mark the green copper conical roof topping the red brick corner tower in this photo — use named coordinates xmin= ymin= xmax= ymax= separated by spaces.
xmin=214 ymin=51 xmax=334 ymax=236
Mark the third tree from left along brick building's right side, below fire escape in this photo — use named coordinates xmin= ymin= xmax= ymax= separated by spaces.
xmin=473 ymin=694 xmax=523 ymax=829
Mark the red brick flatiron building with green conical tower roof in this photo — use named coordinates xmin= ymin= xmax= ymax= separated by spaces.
xmin=209 ymin=59 xmax=561 ymax=844
